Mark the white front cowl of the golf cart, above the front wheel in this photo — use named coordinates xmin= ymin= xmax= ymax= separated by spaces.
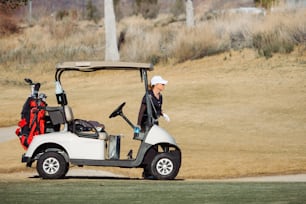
xmin=145 ymin=125 xmax=176 ymax=145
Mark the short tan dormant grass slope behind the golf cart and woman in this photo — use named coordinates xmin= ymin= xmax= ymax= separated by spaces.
xmin=0 ymin=49 xmax=306 ymax=179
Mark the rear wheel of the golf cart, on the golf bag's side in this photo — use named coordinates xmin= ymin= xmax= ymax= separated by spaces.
xmin=36 ymin=152 xmax=69 ymax=179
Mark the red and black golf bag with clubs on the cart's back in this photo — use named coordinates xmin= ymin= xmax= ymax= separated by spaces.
xmin=16 ymin=80 xmax=47 ymax=150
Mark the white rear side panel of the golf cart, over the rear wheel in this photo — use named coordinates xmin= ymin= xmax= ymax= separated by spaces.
xmin=25 ymin=132 xmax=105 ymax=160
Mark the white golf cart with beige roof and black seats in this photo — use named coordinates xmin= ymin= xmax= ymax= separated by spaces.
xmin=22 ymin=61 xmax=181 ymax=180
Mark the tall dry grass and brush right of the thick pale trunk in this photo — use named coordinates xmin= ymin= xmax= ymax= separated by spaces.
xmin=119 ymin=7 xmax=306 ymax=62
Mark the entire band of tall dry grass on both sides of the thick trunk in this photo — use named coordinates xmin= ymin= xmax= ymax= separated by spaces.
xmin=0 ymin=7 xmax=306 ymax=66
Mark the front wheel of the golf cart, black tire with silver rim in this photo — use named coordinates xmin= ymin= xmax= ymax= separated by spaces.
xmin=150 ymin=152 xmax=180 ymax=180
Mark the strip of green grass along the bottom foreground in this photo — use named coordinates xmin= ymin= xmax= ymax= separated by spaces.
xmin=0 ymin=178 xmax=306 ymax=204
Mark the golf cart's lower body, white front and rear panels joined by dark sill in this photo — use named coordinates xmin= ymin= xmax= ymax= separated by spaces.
xmin=24 ymin=125 xmax=177 ymax=167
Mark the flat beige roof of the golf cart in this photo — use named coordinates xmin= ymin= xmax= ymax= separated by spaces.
xmin=56 ymin=61 xmax=153 ymax=72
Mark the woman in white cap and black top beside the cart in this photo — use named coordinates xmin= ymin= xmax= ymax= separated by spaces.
xmin=137 ymin=76 xmax=170 ymax=131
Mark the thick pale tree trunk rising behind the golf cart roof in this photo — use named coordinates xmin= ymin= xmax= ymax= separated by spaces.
xmin=104 ymin=0 xmax=120 ymax=61
